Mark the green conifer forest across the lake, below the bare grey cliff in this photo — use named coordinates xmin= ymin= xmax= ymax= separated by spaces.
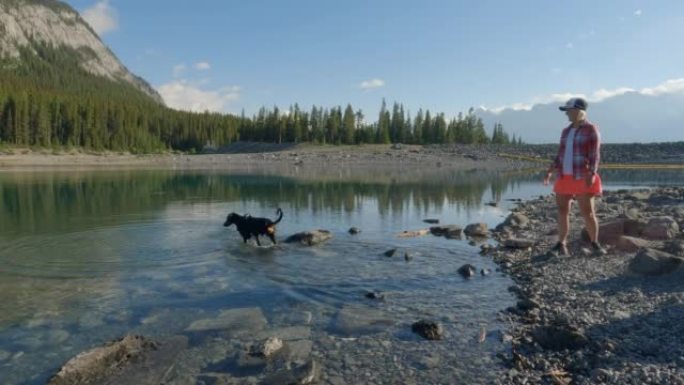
xmin=0 ymin=45 xmax=521 ymax=153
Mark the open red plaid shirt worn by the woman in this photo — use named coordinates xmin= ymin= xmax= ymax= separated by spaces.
xmin=551 ymin=120 xmax=601 ymax=179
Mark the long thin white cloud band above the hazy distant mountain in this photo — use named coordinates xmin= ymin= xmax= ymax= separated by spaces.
xmin=482 ymin=78 xmax=684 ymax=114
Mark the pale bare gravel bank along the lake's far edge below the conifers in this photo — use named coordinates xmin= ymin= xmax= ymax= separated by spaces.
xmin=0 ymin=143 xmax=684 ymax=171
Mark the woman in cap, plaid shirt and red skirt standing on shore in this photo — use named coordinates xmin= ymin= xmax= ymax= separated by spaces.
xmin=544 ymin=98 xmax=606 ymax=256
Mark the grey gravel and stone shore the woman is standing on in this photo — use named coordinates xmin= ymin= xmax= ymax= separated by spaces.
xmin=482 ymin=187 xmax=684 ymax=385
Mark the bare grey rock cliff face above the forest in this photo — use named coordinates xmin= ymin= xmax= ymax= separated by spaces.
xmin=0 ymin=0 xmax=163 ymax=104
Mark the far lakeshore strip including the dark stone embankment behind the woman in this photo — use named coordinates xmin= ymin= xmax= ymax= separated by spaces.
xmin=0 ymin=142 xmax=684 ymax=170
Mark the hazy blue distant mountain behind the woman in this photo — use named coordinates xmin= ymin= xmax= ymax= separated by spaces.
xmin=475 ymin=91 xmax=684 ymax=143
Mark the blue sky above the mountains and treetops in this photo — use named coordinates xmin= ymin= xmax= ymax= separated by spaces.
xmin=62 ymin=0 xmax=684 ymax=121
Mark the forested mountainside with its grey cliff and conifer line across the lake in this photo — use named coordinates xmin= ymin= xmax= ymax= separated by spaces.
xmin=0 ymin=0 xmax=515 ymax=153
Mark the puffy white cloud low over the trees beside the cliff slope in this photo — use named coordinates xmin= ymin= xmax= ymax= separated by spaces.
xmin=157 ymin=80 xmax=242 ymax=112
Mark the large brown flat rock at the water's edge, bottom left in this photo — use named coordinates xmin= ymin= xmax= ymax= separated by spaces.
xmin=48 ymin=336 xmax=187 ymax=385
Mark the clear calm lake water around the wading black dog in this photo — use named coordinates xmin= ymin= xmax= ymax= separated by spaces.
xmin=0 ymin=166 xmax=684 ymax=384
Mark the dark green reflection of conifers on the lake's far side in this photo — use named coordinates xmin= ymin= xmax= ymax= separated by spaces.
xmin=0 ymin=170 xmax=544 ymax=233
